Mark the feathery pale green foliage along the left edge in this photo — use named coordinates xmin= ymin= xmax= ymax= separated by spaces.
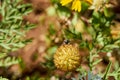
xmin=0 ymin=0 xmax=34 ymax=80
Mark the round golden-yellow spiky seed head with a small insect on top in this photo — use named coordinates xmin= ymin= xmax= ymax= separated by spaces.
xmin=54 ymin=44 xmax=81 ymax=71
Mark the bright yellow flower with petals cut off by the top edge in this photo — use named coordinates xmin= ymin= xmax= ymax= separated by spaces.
xmin=60 ymin=0 xmax=93 ymax=12
